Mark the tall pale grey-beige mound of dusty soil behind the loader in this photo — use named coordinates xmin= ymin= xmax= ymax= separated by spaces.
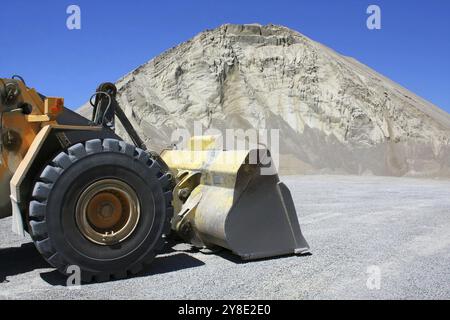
xmin=82 ymin=25 xmax=450 ymax=176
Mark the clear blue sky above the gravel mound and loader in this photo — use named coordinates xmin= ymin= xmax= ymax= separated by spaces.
xmin=0 ymin=0 xmax=450 ymax=112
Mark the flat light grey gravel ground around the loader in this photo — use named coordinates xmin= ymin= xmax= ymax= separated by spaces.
xmin=0 ymin=176 xmax=450 ymax=299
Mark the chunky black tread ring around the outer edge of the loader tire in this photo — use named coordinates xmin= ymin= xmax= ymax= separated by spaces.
xmin=29 ymin=139 xmax=173 ymax=282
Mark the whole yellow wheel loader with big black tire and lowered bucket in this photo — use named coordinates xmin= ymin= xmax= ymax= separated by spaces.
xmin=0 ymin=76 xmax=309 ymax=282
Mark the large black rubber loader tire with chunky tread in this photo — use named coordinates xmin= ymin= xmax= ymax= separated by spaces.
xmin=29 ymin=139 xmax=173 ymax=282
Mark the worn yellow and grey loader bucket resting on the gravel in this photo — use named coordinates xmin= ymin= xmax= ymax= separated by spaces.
xmin=161 ymin=137 xmax=309 ymax=260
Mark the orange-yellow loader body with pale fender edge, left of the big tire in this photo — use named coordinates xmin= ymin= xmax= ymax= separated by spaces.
xmin=0 ymin=79 xmax=102 ymax=231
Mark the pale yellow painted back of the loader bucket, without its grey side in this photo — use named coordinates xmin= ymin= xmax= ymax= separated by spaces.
xmin=161 ymin=136 xmax=249 ymax=246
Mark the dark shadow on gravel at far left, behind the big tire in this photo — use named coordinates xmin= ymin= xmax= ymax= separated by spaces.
xmin=0 ymin=243 xmax=49 ymax=283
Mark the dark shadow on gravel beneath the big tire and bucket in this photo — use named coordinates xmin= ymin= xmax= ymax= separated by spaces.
xmin=41 ymin=253 xmax=205 ymax=287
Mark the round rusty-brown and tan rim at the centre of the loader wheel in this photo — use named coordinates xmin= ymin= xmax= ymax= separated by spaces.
xmin=76 ymin=179 xmax=140 ymax=245
